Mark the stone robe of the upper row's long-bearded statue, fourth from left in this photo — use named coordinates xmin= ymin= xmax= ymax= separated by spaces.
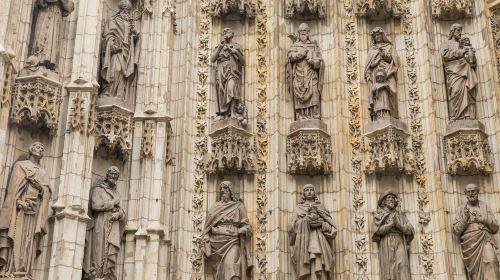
xmin=286 ymin=40 xmax=325 ymax=109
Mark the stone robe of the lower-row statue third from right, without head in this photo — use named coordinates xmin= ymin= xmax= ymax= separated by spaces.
xmin=288 ymin=202 xmax=337 ymax=279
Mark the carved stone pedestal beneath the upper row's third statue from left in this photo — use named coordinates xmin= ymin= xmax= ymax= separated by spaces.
xmin=206 ymin=118 xmax=256 ymax=174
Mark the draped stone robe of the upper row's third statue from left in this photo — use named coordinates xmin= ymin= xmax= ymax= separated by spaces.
xmin=215 ymin=43 xmax=243 ymax=115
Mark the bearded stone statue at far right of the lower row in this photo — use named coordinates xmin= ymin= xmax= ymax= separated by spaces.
xmin=453 ymin=184 xmax=500 ymax=280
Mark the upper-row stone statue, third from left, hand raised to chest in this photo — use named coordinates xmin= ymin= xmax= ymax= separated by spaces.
xmin=212 ymin=27 xmax=245 ymax=122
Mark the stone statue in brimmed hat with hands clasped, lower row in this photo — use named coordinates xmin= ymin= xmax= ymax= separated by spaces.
xmin=372 ymin=191 xmax=415 ymax=280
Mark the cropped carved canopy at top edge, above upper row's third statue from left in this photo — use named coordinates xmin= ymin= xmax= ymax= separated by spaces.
xmin=208 ymin=0 xmax=257 ymax=18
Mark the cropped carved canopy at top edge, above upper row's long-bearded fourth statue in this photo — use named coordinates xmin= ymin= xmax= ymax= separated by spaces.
xmin=285 ymin=0 xmax=326 ymax=20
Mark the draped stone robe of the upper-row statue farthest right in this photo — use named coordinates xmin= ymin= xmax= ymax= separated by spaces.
xmin=441 ymin=40 xmax=478 ymax=120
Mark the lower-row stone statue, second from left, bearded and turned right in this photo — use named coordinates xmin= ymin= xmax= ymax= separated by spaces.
xmin=83 ymin=166 xmax=126 ymax=280
